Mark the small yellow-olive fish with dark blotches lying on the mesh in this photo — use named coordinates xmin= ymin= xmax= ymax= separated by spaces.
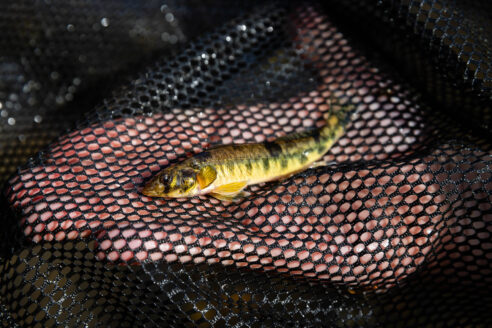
xmin=142 ymin=104 xmax=351 ymax=201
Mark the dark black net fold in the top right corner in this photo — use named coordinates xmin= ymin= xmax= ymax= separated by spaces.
xmin=327 ymin=0 xmax=492 ymax=131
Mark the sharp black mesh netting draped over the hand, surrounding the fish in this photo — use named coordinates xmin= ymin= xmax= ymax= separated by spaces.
xmin=0 ymin=0 xmax=492 ymax=326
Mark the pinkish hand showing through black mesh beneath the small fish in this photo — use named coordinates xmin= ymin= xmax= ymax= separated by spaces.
xmin=10 ymin=88 xmax=460 ymax=286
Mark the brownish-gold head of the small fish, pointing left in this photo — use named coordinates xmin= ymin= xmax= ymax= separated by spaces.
xmin=142 ymin=166 xmax=199 ymax=198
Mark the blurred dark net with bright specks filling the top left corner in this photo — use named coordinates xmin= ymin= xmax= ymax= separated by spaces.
xmin=0 ymin=0 xmax=250 ymax=184
